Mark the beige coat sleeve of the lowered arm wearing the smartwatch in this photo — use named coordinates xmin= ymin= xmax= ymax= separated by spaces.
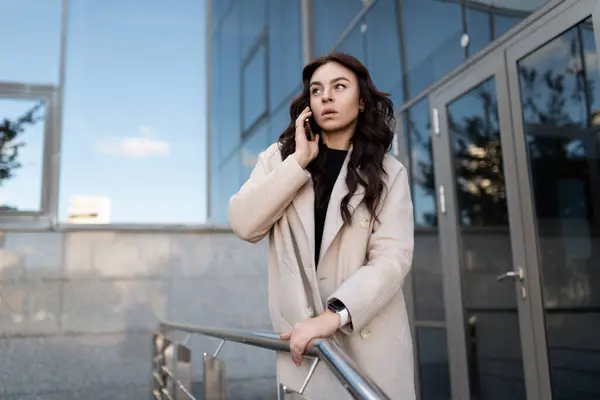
xmin=328 ymin=167 xmax=414 ymax=334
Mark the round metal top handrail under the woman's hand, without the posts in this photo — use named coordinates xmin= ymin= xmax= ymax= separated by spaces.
xmin=160 ymin=321 xmax=389 ymax=400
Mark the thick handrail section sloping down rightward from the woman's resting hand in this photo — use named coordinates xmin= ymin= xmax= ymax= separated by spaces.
xmin=315 ymin=340 xmax=390 ymax=400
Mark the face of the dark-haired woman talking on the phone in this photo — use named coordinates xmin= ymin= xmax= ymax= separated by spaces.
xmin=309 ymin=62 xmax=361 ymax=132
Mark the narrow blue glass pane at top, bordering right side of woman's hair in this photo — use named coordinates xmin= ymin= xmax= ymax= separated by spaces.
xmin=366 ymin=0 xmax=404 ymax=105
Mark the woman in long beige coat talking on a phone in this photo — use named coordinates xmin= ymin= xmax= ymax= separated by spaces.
xmin=229 ymin=53 xmax=415 ymax=400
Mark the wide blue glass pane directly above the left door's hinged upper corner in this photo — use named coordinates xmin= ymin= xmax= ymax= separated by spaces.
xmin=401 ymin=0 xmax=464 ymax=97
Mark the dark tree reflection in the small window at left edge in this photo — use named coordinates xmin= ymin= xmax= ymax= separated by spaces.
xmin=0 ymin=101 xmax=44 ymax=210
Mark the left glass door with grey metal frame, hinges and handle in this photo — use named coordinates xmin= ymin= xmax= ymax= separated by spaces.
xmin=431 ymin=52 xmax=538 ymax=400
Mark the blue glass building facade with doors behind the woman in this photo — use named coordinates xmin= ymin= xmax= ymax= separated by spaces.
xmin=210 ymin=0 xmax=600 ymax=399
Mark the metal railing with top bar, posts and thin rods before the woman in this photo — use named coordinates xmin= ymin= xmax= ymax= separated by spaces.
xmin=152 ymin=321 xmax=389 ymax=400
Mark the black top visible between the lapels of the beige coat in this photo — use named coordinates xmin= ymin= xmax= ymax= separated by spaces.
xmin=315 ymin=147 xmax=348 ymax=265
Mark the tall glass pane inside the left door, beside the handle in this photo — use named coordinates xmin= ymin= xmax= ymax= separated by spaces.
xmin=448 ymin=79 xmax=525 ymax=400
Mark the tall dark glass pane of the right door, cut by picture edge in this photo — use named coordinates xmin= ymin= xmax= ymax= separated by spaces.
xmin=518 ymin=21 xmax=600 ymax=399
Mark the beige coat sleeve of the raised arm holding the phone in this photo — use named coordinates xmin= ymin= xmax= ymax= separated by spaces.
xmin=229 ymin=146 xmax=310 ymax=243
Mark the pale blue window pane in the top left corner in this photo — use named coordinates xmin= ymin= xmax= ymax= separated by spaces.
xmin=0 ymin=0 xmax=62 ymax=84
